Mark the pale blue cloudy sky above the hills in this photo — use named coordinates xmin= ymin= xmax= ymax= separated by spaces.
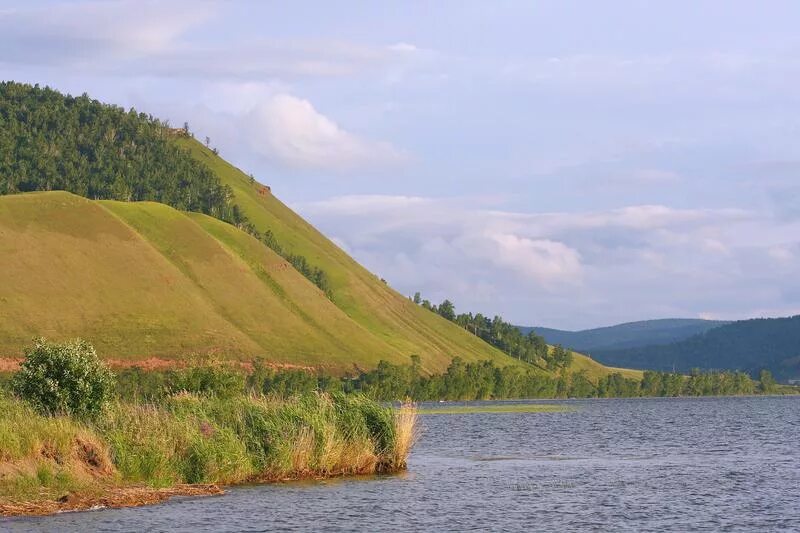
xmin=0 ymin=0 xmax=800 ymax=329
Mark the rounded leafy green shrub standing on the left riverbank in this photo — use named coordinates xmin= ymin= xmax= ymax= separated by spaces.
xmin=12 ymin=339 xmax=114 ymax=417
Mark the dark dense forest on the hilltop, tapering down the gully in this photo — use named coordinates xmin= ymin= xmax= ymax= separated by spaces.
xmin=0 ymin=82 xmax=331 ymax=297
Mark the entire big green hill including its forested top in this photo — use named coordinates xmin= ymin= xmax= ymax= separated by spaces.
xmin=0 ymin=79 xmax=639 ymax=377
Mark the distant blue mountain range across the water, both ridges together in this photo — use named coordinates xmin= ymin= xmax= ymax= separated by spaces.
xmin=523 ymin=315 xmax=800 ymax=381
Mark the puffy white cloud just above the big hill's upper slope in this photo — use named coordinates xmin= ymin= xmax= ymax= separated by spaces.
xmin=135 ymin=82 xmax=410 ymax=172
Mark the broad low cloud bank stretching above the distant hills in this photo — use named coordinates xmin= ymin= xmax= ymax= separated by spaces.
xmin=295 ymin=195 xmax=800 ymax=327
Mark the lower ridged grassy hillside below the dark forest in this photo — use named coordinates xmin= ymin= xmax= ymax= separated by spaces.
xmin=0 ymin=192 xmax=513 ymax=371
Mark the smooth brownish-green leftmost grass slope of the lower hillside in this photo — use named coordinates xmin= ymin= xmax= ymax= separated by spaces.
xmin=0 ymin=192 xmax=256 ymax=357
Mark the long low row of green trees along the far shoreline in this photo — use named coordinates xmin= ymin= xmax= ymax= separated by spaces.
xmin=106 ymin=356 xmax=776 ymax=401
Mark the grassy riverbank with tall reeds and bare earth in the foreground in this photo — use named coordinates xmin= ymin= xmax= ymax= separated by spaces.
xmin=0 ymin=394 xmax=416 ymax=515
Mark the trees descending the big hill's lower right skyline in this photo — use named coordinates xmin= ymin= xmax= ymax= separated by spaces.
xmin=412 ymin=292 xmax=572 ymax=371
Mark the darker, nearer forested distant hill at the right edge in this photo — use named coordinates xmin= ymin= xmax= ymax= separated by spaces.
xmin=592 ymin=316 xmax=800 ymax=380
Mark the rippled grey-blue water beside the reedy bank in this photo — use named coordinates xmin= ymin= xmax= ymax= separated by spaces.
xmin=7 ymin=397 xmax=800 ymax=532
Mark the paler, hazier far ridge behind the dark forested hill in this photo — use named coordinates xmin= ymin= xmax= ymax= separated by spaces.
xmin=519 ymin=318 xmax=728 ymax=353
